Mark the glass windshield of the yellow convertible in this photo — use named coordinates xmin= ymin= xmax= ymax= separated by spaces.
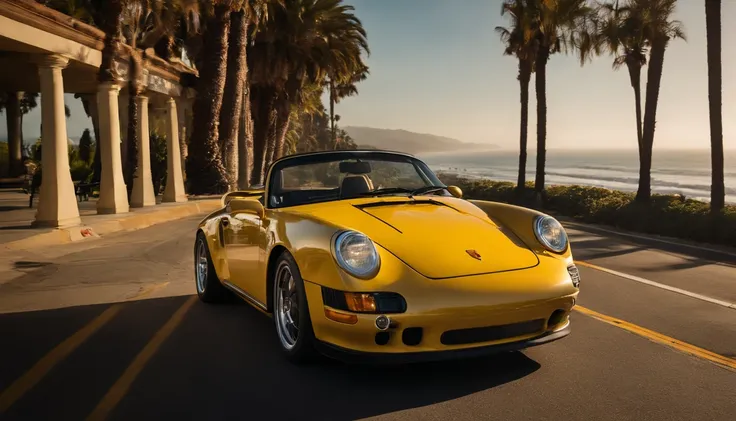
xmin=268 ymin=151 xmax=449 ymax=208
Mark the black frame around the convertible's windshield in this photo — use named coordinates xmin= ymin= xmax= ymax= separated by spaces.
xmin=263 ymin=150 xmax=449 ymax=209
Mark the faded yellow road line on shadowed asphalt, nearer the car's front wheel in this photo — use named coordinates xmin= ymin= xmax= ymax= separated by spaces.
xmin=87 ymin=296 xmax=197 ymax=421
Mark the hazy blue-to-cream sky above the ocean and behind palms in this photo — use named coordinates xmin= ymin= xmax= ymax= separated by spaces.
xmin=0 ymin=0 xmax=736 ymax=149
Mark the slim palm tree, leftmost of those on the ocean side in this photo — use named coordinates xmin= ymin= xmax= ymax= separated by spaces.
xmin=496 ymin=0 xmax=536 ymax=193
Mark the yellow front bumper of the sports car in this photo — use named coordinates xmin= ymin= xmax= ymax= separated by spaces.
xmin=305 ymin=282 xmax=578 ymax=361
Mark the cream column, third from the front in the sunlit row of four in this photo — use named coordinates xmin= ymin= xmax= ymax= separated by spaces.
xmin=130 ymin=95 xmax=156 ymax=208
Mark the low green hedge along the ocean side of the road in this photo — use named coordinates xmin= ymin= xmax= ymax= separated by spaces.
xmin=439 ymin=174 xmax=736 ymax=246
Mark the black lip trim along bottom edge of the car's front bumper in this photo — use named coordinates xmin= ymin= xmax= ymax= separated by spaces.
xmin=315 ymin=323 xmax=570 ymax=364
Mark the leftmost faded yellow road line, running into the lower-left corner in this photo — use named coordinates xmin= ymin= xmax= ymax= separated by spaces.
xmin=0 ymin=304 xmax=123 ymax=414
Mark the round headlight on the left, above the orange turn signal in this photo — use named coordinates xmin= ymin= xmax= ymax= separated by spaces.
xmin=334 ymin=231 xmax=381 ymax=279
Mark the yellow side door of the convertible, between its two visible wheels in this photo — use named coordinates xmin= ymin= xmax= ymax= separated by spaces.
xmin=221 ymin=202 xmax=266 ymax=305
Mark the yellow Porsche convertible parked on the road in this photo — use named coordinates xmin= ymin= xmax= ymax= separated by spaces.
xmin=194 ymin=150 xmax=580 ymax=362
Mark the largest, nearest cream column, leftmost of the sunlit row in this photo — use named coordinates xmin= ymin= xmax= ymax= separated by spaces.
xmin=31 ymin=56 xmax=81 ymax=228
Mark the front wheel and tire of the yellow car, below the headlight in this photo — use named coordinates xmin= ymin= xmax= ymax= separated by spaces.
xmin=272 ymin=251 xmax=316 ymax=363
